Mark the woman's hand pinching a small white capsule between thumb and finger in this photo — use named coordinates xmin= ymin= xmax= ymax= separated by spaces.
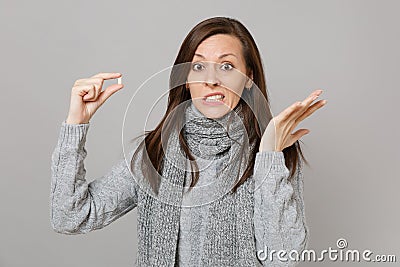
xmin=66 ymin=73 xmax=124 ymax=124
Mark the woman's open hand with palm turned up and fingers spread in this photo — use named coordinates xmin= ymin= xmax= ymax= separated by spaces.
xmin=259 ymin=90 xmax=327 ymax=151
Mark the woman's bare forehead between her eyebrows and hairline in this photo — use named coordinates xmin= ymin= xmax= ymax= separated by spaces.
xmin=195 ymin=34 xmax=242 ymax=58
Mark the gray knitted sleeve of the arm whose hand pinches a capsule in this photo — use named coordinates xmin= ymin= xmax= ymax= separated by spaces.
xmin=50 ymin=121 xmax=137 ymax=234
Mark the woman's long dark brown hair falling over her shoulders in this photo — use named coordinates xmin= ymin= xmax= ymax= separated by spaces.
xmin=131 ymin=17 xmax=308 ymax=197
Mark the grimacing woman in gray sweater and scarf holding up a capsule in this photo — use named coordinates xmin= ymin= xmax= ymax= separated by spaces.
xmin=51 ymin=17 xmax=326 ymax=266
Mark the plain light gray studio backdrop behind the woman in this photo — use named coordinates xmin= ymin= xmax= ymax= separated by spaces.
xmin=0 ymin=0 xmax=400 ymax=267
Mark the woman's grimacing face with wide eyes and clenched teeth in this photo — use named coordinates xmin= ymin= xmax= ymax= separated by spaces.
xmin=187 ymin=34 xmax=253 ymax=118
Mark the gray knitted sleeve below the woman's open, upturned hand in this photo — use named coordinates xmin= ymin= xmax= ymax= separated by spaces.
xmin=254 ymin=151 xmax=309 ymax=266
